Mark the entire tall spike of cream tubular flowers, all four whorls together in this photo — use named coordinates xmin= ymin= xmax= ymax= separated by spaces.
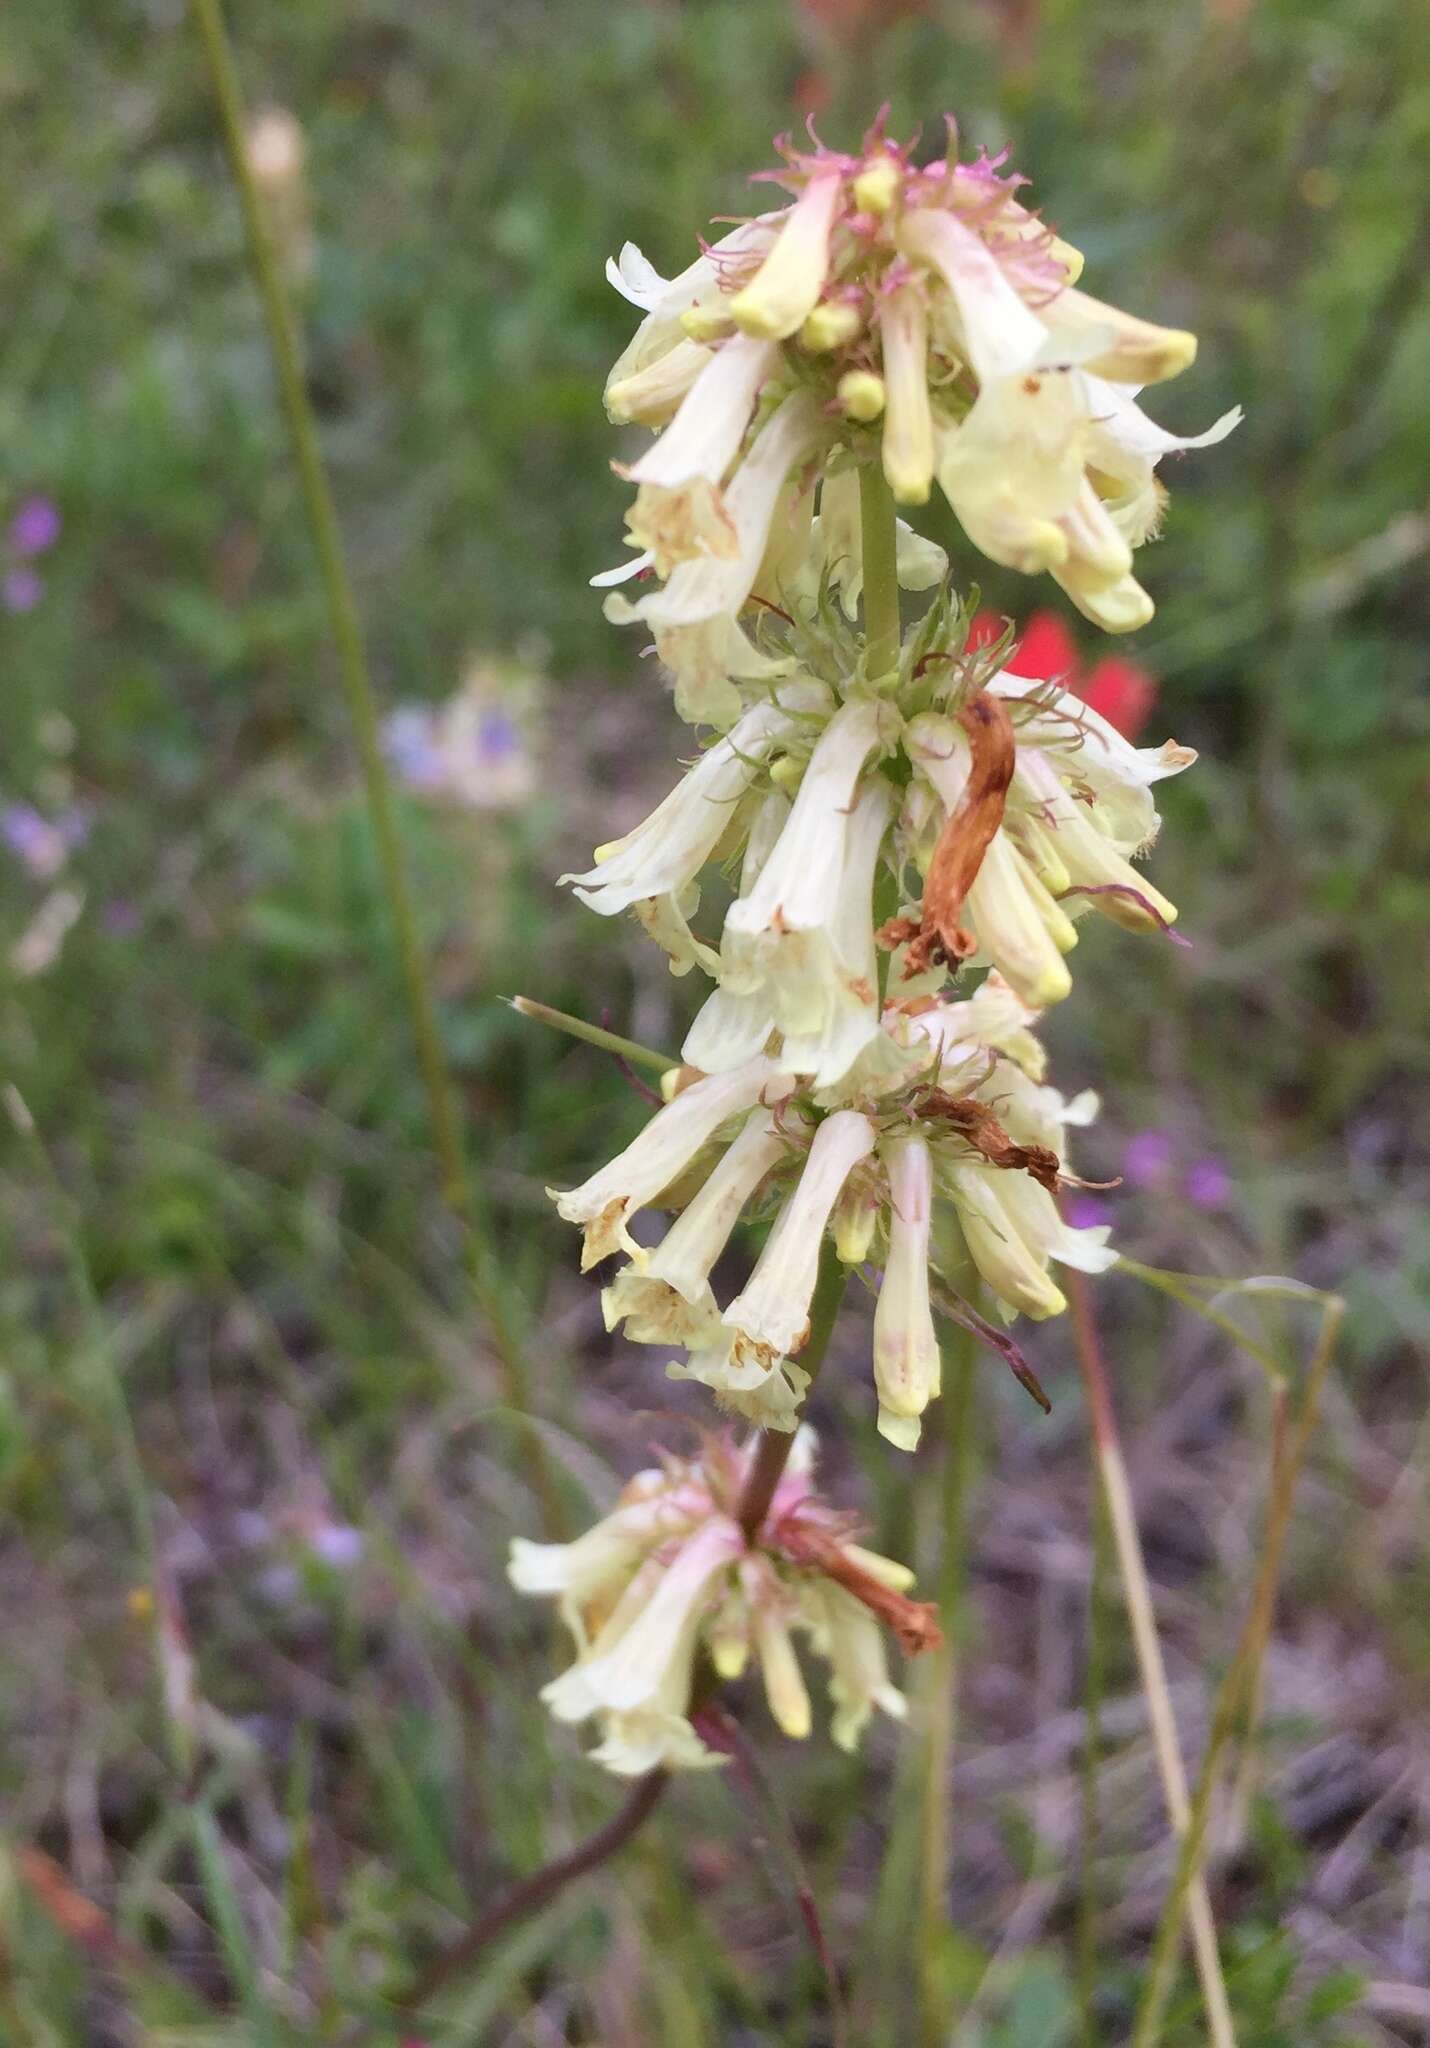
xmin=512 ymin=125 xmax=1239 ymax=1774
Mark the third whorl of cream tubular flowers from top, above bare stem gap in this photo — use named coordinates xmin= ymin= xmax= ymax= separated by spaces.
xmin=555 ymin=973 xmax=1114 ymax=1450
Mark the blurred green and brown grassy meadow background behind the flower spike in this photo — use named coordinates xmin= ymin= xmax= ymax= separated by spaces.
xmin=0 ymin=0 xmax=1430 ymax=2048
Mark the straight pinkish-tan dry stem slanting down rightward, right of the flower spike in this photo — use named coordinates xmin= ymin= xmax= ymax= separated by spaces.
xmin=1067 ymin=1272 xmax=1235 ymax=2048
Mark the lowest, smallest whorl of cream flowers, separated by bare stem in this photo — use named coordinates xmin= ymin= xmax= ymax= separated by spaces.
xmin=510 ymin=1430 xmax=938 ymax=1778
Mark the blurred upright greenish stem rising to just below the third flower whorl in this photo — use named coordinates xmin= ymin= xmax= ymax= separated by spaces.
xmin=918 ymin=1329 xmax=977 ymax=2048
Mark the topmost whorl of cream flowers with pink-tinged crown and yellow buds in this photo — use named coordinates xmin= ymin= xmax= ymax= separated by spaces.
xmin=598 ymin=125 xmax=1239 ymax=725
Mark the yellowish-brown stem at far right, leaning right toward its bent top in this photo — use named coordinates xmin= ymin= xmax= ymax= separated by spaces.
xmin=1131 ymin=1296 xmax=1344 ymax=2048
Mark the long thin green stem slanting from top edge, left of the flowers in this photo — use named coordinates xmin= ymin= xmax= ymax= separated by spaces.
xmin=193 ymin=0 xmax=551 ymax=1474
